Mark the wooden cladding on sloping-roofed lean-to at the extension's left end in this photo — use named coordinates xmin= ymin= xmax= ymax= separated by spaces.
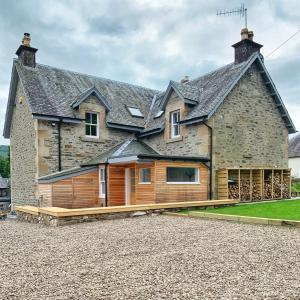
xmin=38 ymin=171 xmax=100 ymax=208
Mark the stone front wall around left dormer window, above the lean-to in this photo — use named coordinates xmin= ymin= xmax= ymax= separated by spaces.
xmin=38 ymin=96 xmax=131 ymax=176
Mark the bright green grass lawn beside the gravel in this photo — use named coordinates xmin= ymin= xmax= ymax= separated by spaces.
xmin=181 ymin=200 xmax=300 ymax=221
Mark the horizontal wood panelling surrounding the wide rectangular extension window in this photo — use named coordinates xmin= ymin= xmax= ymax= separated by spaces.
xmin=155 ymin=161 xmax=208 ymax=203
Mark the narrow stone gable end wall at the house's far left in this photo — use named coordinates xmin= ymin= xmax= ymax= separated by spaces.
xmin=10 ymin=82 xmax=37 ymax=205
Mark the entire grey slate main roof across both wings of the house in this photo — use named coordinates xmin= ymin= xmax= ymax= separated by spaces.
xmin=4 ymin=53 xmax=296 ymax=137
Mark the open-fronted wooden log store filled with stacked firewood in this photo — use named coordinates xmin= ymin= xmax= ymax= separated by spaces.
xmin=217 ymin=169 xmax=291 ymax=202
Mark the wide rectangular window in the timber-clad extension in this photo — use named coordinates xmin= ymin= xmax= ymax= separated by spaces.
xmin=167 ymin=167 xmax=199 ymax=184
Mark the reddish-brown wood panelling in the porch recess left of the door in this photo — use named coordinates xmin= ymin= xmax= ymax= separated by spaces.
xmin=107 ymin=166 xmax=125 ymax=206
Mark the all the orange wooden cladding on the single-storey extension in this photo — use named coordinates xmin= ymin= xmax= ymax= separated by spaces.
xmin=39 ymin=161 xmax=209 ymax=208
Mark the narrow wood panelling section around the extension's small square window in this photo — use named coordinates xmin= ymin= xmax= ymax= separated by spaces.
xmin=135 ymin=163 xmax=155 ymax=204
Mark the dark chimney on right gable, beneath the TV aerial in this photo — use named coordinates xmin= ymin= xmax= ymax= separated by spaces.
xmin=232 ymin=28 xmax=262 ymax=64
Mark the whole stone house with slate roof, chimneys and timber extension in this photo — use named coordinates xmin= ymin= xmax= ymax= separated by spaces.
xmin=4 ymin=29 xmax=295 ymax=207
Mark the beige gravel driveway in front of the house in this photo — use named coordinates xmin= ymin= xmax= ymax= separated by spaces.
xmin=0 ymin=216 xmax=300 ymax=300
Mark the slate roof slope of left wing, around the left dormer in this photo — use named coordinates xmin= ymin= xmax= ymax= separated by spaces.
xmin=14 ymin=60 xmax=158 ymax=127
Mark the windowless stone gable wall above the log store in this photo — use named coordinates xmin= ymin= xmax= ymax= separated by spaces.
xmin=210 ymin=65 xmax=288 ymax=169
